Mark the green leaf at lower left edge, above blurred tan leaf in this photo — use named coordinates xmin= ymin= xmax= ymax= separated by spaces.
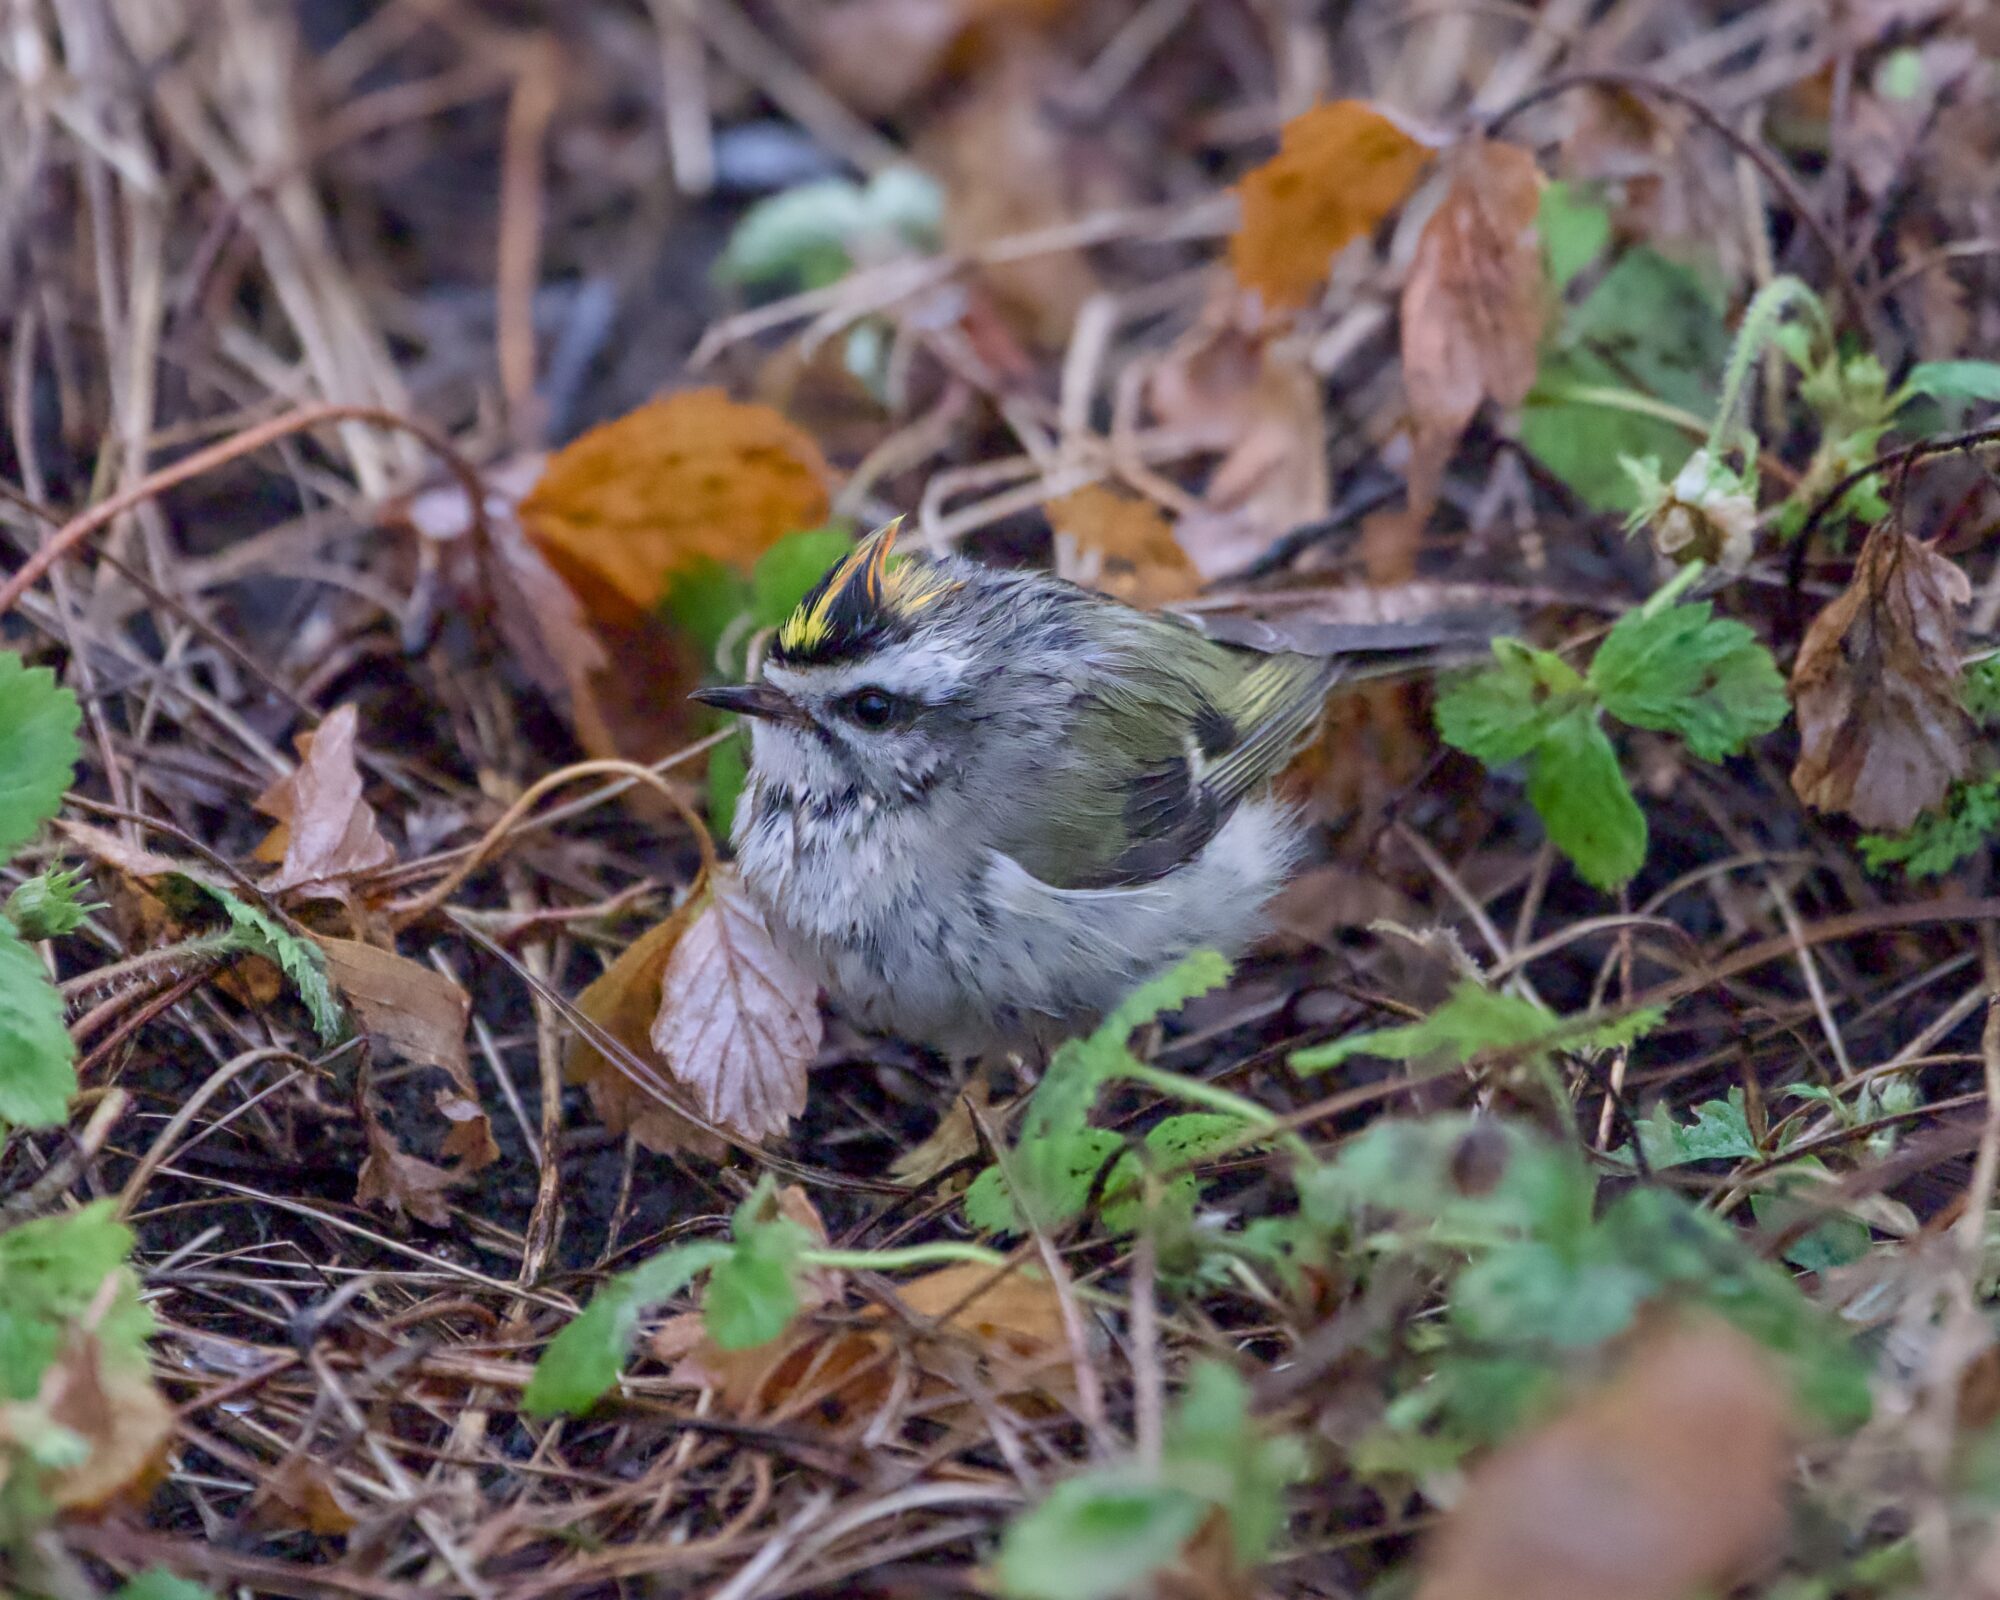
xmin=0 ymin=1200 xmax=152 ymax=1400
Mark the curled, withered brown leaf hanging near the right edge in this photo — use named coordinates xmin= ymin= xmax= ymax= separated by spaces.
xmin=1792 ymin=524 xmax=1974 ymax=834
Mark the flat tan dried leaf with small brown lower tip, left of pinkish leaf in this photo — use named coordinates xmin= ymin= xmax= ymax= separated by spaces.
xmin=318 ymin=938 xmax=500 ymax=1172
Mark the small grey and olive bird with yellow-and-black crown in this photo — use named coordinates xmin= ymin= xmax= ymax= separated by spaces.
xmin=694 ymin=522 xmax=1456 ymax=1052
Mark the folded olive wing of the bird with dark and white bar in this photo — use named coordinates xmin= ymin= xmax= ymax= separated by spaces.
xmin=1008 ymin=638 xmax=1336 ymax=888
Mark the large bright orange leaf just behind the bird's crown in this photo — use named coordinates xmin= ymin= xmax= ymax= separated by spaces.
xmin=520 ymin=388 xmax=830 ymax=622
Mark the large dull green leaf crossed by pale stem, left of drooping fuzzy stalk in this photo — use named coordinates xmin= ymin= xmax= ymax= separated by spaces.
xmin=1520 ymin=248 xmax=1730 ymax=514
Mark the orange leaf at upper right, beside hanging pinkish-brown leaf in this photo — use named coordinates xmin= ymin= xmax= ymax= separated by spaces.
xmin=1230 ymin=100 xmax=1430 ymax=308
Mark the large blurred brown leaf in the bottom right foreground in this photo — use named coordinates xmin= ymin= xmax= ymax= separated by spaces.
xmin=1416 ymin=1316 xmax=1792 ymax=1600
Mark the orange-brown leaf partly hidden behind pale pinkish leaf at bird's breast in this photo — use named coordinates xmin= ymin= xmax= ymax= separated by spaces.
xmin=562 ymin=896 xmax=726 ymax=1160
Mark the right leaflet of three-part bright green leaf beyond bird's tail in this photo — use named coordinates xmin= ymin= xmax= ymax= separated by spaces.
xmin=1590 ymin=600 xmax=1790 ymax=762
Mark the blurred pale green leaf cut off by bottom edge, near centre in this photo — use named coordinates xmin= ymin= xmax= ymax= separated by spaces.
xmin=994 ymin=1468 xmax=1208 ymax=1600
